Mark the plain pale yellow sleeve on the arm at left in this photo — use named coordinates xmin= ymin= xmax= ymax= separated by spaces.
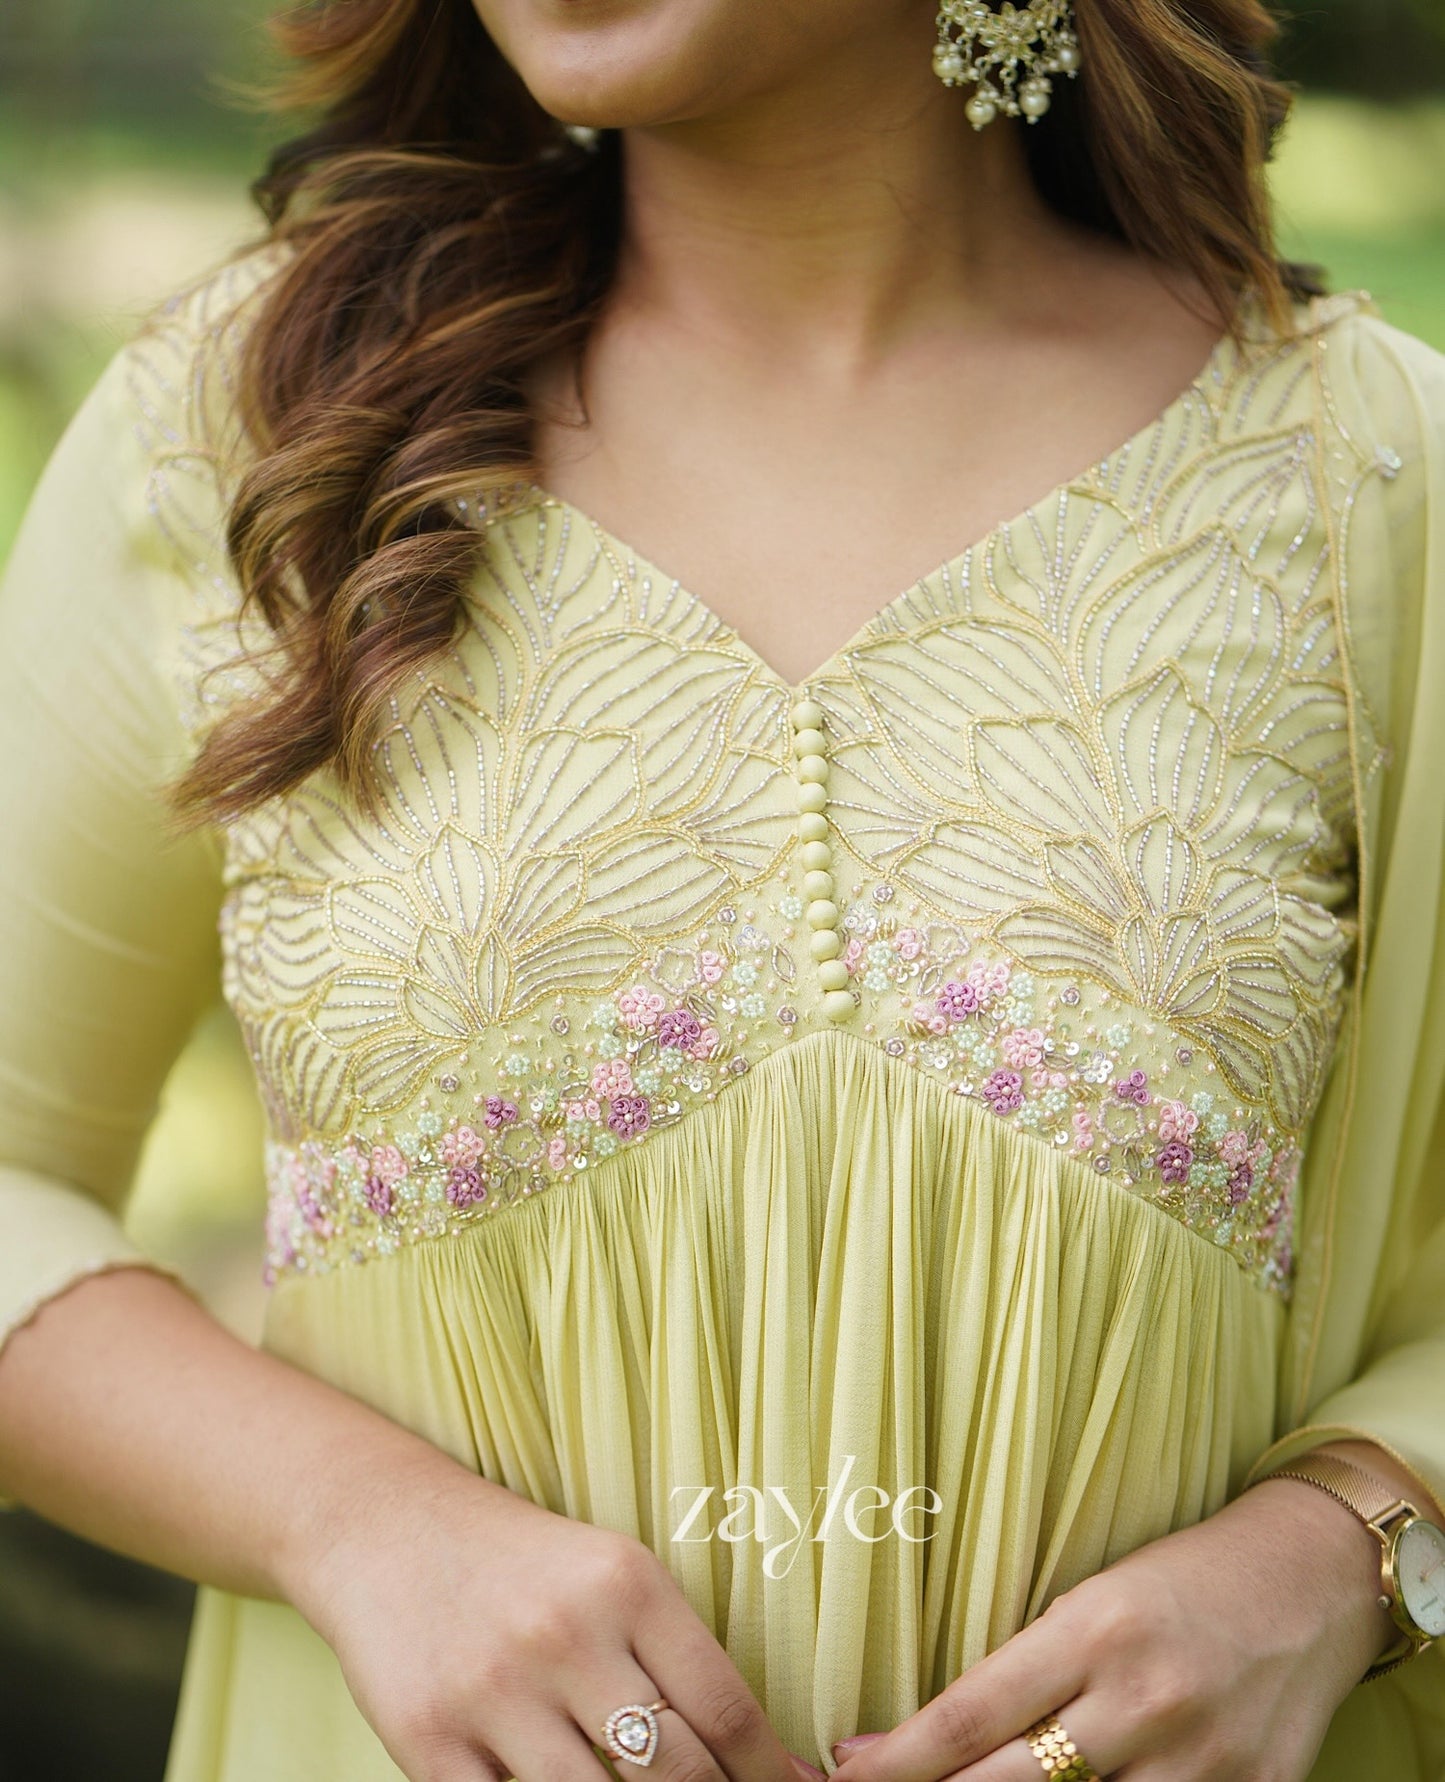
xmin=0 ymin=324 xmax=221 ymax=1375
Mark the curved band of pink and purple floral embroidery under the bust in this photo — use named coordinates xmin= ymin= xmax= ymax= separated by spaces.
xmin=256 ymin=895 xmax=1299 ymax=1290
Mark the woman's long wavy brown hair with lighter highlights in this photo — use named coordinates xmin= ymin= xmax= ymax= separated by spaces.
xmin=173 ymin=0 xmax=1318 ymax=822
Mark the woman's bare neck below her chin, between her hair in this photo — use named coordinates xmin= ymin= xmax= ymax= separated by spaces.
xmin=615 ymin=39 xmax=1065 ymax=372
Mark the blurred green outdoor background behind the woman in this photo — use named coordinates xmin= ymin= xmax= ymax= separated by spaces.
xmin=0 ymin=0 xmax=1445 ymax=1782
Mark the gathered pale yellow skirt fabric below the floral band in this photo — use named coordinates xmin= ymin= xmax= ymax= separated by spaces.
xmin=169 ymin=1032 xmax=1283 ymax=1782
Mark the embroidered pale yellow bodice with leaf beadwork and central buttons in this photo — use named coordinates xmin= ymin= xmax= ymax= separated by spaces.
xmin=158 ymin=292 xmax=1368 ymax=1292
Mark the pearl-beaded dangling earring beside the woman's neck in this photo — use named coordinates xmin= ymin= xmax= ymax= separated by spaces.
xmin=934 ymin=0 xmax=1082 ymax=130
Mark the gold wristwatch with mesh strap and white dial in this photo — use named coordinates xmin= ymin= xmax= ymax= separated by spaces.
xmin=1265 ymin=1454 xmax=1445 ymax=1682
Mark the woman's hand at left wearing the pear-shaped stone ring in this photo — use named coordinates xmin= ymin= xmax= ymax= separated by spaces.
xmin=292 ymin=1463 xmax=821 ymax=1782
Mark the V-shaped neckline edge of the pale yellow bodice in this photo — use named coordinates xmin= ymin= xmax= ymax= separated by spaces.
xmin=511 ymin=319 xmax=1247 ymax=699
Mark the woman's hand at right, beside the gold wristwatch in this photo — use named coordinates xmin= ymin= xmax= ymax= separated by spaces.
xmin=834 ymin=1479 xmax=1399 ymax=1782
